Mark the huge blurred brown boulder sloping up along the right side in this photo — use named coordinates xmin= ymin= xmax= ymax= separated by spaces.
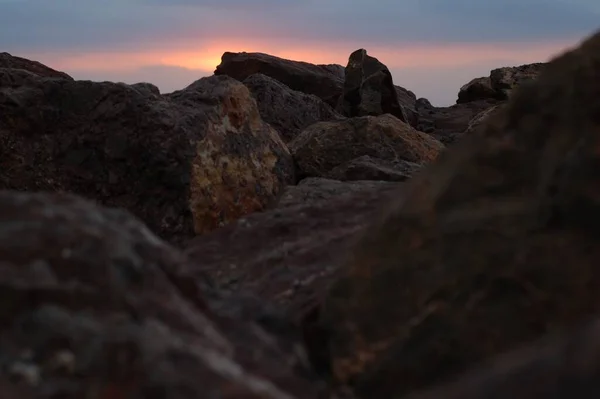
xmin=320 ymin=28 xmax=600 ymax=399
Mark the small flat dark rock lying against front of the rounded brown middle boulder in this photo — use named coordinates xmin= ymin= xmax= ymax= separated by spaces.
xmin=326 ymin=155 xmax=422 ymax=181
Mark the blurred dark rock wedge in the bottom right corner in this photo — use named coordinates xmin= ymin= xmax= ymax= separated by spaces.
xmin=406 ymin=321 xmax=600 ymax=399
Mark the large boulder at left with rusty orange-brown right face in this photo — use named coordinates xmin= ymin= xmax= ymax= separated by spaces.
xmin=0 ymin=70 xmax=295 ymax=244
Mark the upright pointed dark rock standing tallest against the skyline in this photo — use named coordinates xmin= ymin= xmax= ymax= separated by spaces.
xmin=339 ymin=49 xmax=417 ymax=126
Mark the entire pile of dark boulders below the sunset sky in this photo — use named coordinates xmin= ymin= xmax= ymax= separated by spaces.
xmin=0 ymin=26 xmax=600 ymax=399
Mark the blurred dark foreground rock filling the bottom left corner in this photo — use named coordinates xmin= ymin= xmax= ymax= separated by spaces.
xmin=0 ymin=191 xmax=318 ymax=399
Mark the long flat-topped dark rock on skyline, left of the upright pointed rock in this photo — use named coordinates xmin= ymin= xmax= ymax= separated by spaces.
xmin=215 ymin=52 xmax=344 ymax=106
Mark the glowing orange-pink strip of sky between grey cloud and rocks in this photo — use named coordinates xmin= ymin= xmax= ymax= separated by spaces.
xmin=10 ymin=38 xmax=582 ymax=107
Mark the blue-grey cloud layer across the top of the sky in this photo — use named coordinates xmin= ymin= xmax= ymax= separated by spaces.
xmin=0 ymin=0 xmax=600 ymax=52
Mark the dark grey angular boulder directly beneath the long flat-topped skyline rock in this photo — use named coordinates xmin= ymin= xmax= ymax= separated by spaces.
xmin=243 ymin=73 xmax=343 ymax=143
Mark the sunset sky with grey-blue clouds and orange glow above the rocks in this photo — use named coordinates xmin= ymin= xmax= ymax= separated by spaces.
xmin=0 ymin=0 xmax=600 ymax=106
